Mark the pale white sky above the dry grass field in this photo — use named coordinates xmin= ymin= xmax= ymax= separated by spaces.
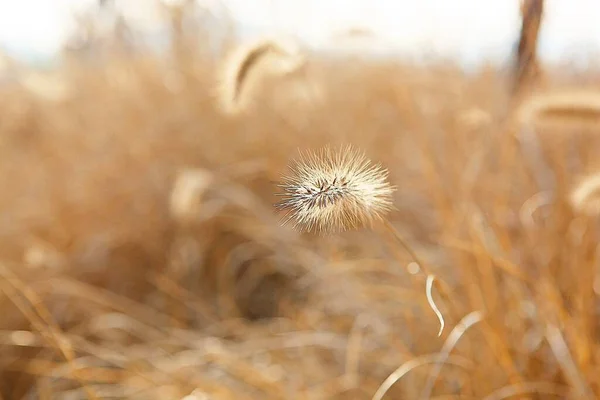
xmin=0 ymin=0 xmax=600 ymax=64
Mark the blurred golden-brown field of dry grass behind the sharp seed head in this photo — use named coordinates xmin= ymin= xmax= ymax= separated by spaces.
xmin=0 ymin=11 xmax=600 ymax=400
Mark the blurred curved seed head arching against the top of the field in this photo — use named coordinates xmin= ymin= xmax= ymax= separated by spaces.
xmin=217 ymin=38 xmax=305 ymax=114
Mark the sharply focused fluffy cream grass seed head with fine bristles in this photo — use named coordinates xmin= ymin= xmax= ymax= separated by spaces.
xmin=276 ymin=146 xmax=395 ymax=233
